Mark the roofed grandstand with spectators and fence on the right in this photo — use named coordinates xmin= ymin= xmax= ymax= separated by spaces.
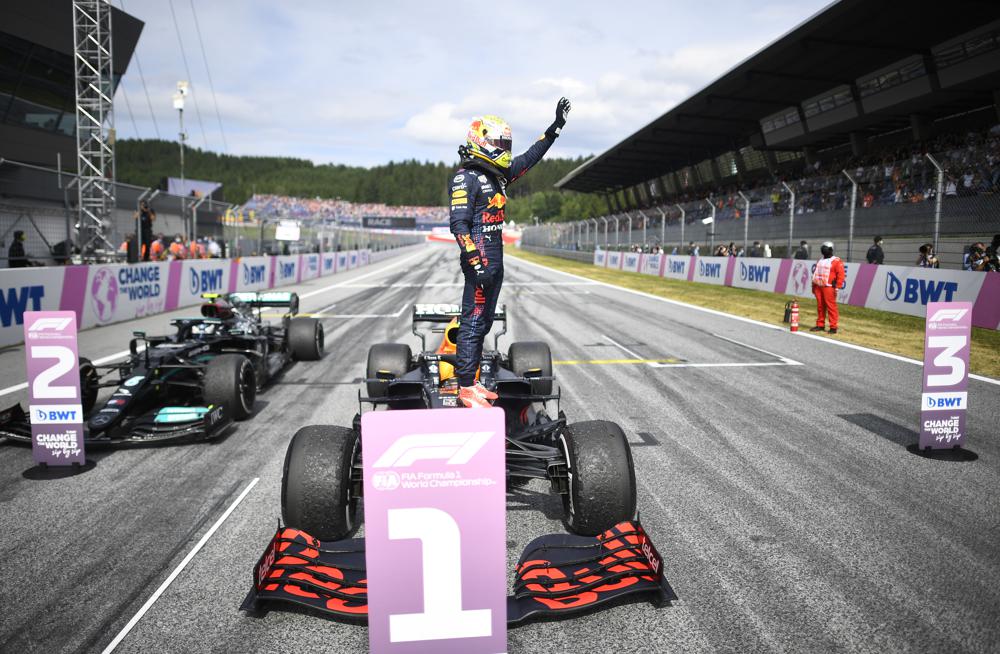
xmin=540 ymin=0 xmax=1000 ymax=268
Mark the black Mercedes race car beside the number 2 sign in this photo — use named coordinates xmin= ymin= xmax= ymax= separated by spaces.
xmin=0 ymin=291 xmax=323 ymax=447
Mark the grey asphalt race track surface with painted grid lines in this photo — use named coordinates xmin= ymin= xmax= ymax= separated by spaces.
xmin=0 ymin=245 xmax=1000 ymax=652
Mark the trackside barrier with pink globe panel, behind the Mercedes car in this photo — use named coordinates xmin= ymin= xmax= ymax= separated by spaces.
xmin=0 ymin=244 xmax=423 ymax=347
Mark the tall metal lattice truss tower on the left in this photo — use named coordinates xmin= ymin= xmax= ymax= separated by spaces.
xmin=73 ymin=0 xmax=115 ymax=259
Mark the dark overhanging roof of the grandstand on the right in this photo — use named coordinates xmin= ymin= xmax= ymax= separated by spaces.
xmin=556 ymin=0 xmax=1000 ymax=192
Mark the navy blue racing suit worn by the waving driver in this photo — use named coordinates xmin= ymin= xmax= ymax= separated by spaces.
xmin=448 ymin=134 xmax=558 ymax=386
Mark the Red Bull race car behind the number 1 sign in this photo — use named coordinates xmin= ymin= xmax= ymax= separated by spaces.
xmin=242 ymin=304 xmax=675 ymax=624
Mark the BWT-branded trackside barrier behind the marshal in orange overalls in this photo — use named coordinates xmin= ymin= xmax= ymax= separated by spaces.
xmin=594 ymin=250 xmax=1000 ymax=329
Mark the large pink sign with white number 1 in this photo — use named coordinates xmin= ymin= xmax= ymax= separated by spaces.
xmin=361 ymin=409 xmax=507 ymax=654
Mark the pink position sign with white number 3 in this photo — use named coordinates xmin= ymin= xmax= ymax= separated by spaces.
xmin=920 ymin=302 xmax=972 ymax=450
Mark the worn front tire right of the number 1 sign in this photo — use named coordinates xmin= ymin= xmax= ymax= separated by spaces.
xmin=559 ymin=420 xmax=635 ymax=536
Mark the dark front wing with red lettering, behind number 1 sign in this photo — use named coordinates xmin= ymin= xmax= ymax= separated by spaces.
xmin=240 ymin=522 xmax=677 ymax=625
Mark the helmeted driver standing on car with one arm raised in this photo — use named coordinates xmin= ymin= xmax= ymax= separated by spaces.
xmin=449 ymin=98 xmax=570 ymax=408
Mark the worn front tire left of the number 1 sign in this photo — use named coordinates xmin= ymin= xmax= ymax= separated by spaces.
xmin=281 ymin=425 xmax=361 ymax=540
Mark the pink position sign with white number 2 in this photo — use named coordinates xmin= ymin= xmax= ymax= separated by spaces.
xmin=24 ymin=311 xmax=87 ymax=466
